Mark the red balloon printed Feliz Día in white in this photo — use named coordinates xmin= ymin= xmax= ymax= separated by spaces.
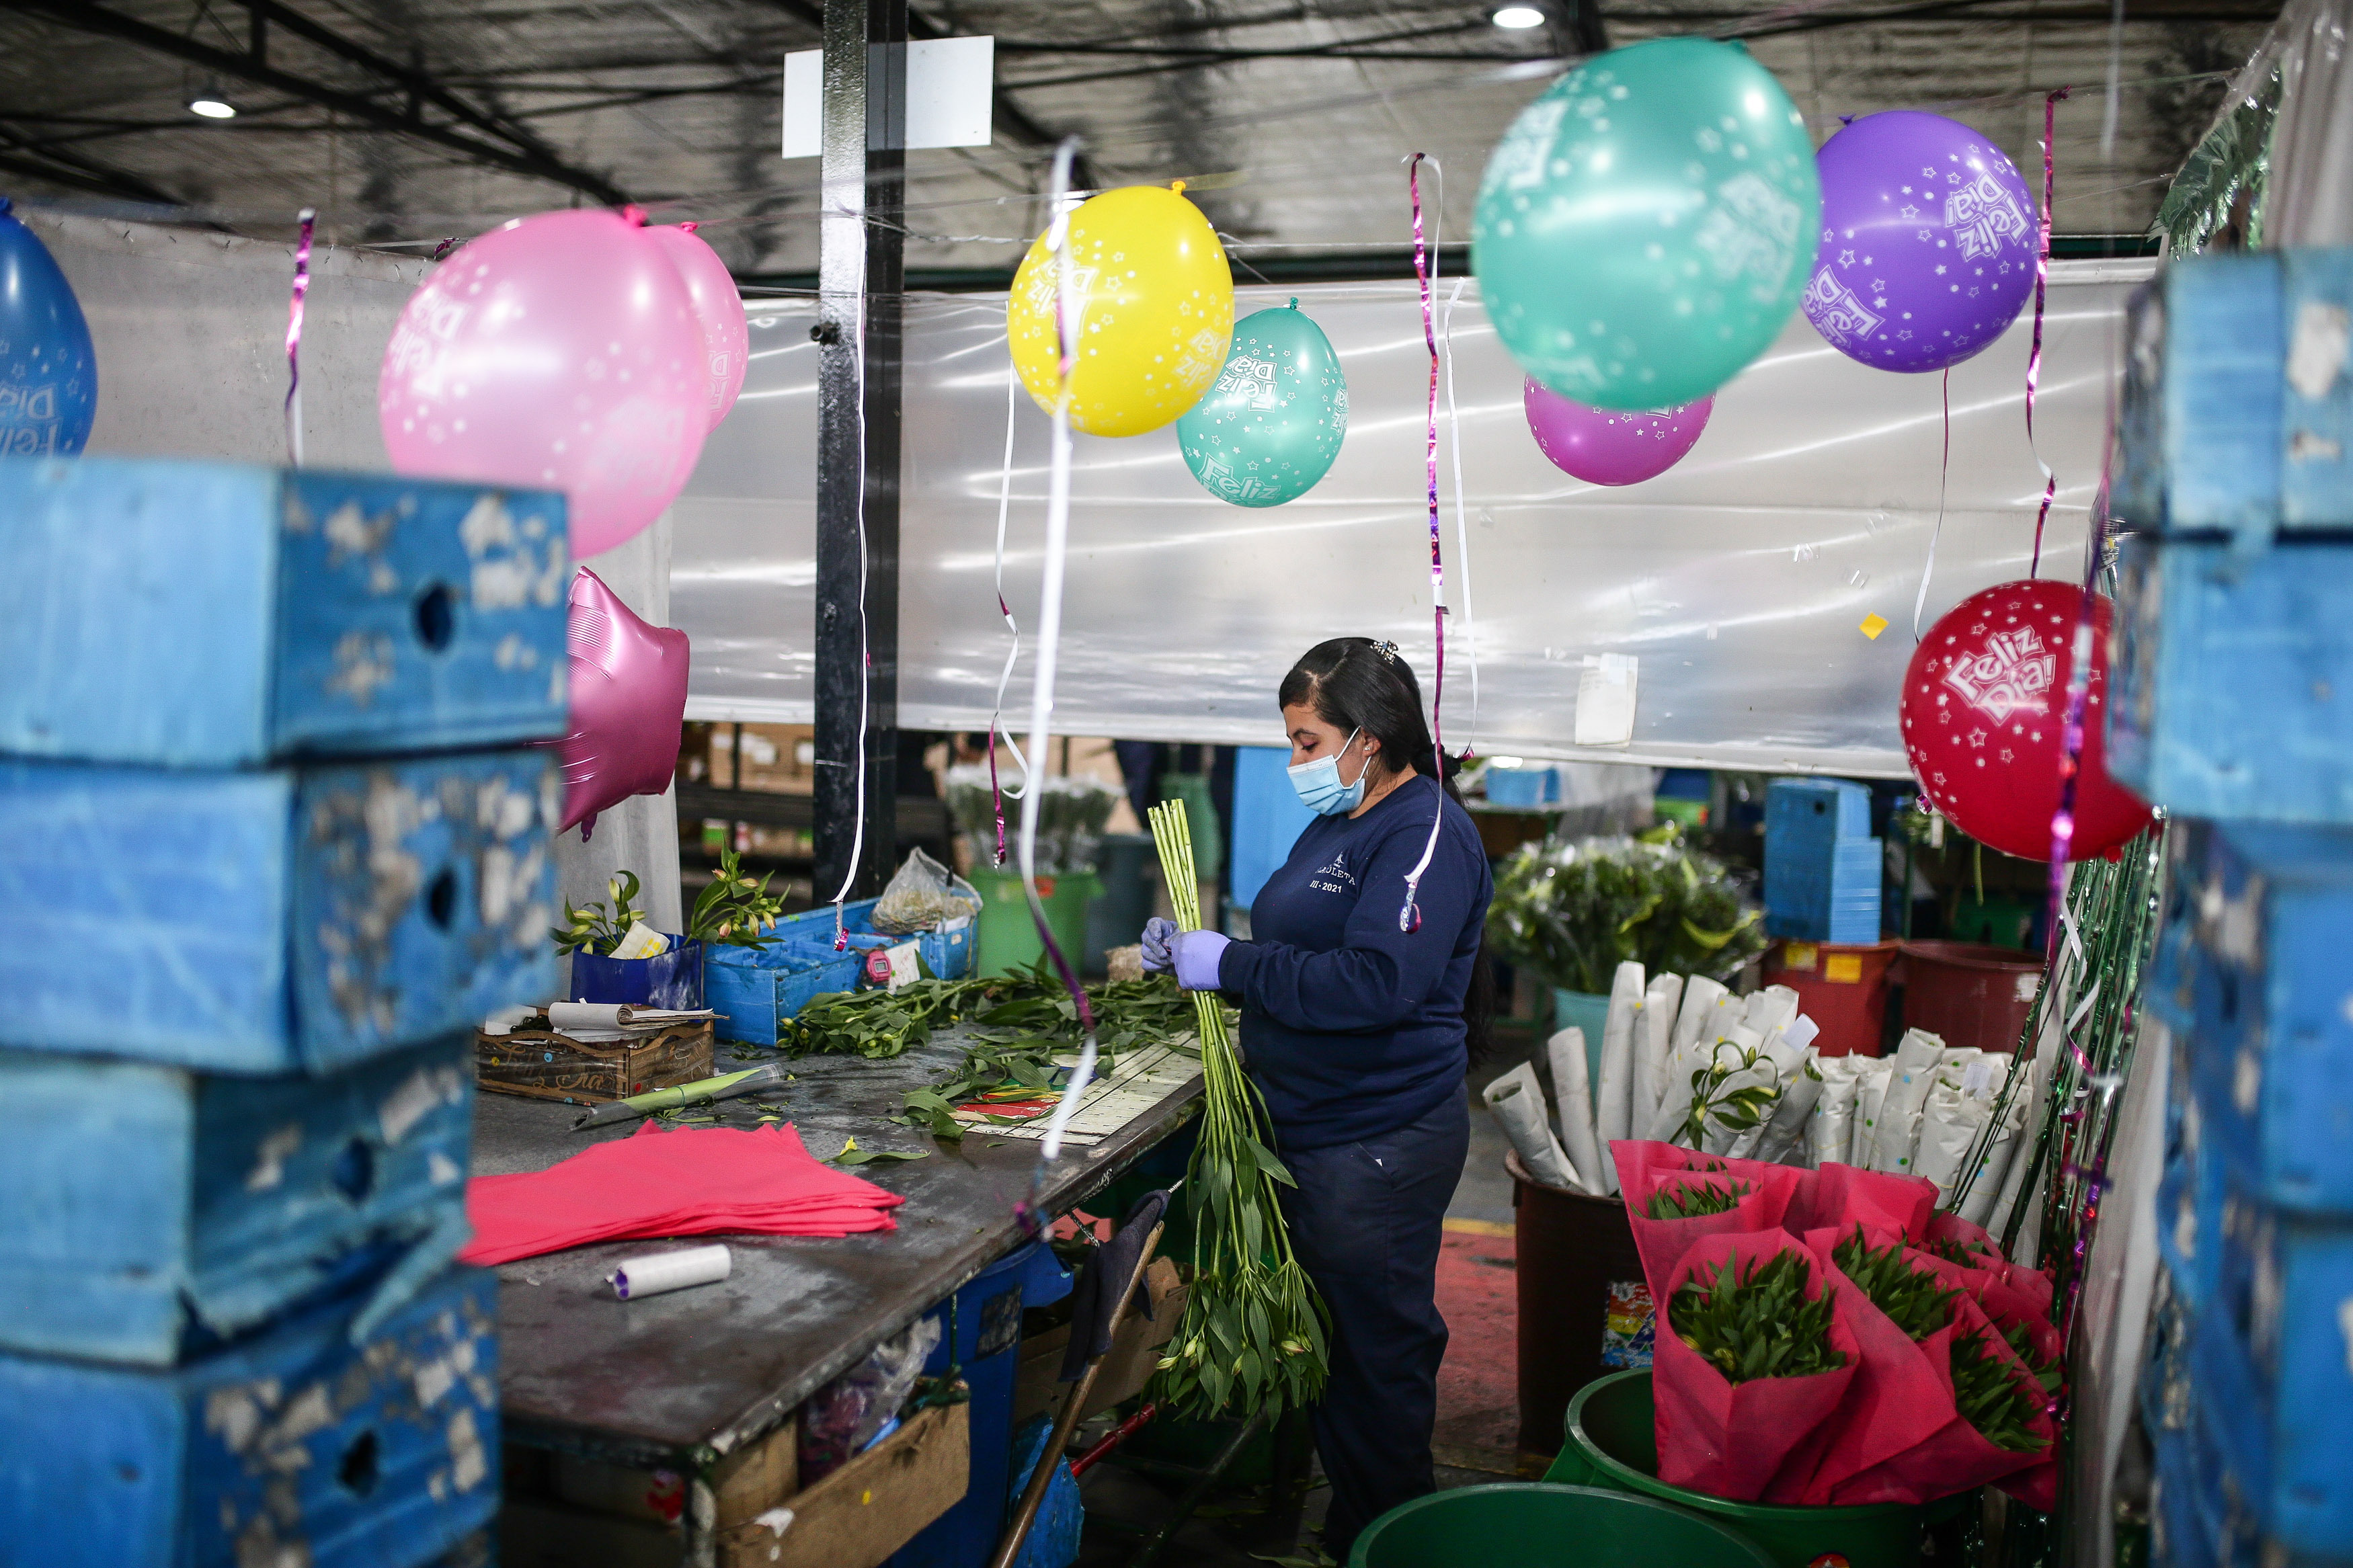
xmin=1899 ymin=581 xmax=2149 ymax=860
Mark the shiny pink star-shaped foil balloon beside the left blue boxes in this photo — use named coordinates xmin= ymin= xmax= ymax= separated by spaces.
xmin=563 ymin=567 xmax=690 ymax=839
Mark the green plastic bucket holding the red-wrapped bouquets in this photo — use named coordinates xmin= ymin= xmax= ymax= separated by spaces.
xmin=1544 ymin=1368 xmax=1951 ymax=1568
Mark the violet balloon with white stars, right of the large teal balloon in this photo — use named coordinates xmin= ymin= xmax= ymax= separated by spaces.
xmin=1805 ymin=108 xmax=2038 ymax=372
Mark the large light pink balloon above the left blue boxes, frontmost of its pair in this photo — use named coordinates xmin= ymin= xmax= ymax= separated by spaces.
xmin=376 ymin=212 xmax=711 ymax=559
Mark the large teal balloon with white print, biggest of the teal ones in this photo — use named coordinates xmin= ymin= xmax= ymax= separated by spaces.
xmin=1471 ymin=38 xmax=1821 ymax=409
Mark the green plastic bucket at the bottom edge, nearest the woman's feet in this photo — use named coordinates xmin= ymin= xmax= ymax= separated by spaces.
xmin=1349 ymin=1481 xmax=1774 ymax=1568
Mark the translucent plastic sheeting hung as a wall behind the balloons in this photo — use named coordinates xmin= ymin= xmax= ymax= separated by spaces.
xmin=673 ymin=261 xmax=2151 ymax=776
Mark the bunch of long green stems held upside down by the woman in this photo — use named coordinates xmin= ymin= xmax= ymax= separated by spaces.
xmin=1151 ymin=802 xmax=1327 ymax=1417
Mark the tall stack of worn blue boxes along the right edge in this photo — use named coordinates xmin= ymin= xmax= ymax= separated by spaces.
xmin=2108 ymin=249 xmax=2353 ymax=1568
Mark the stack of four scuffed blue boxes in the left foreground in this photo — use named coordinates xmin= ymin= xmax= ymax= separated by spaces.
xmin=0 ymin=458 xmax=569 ymax=1568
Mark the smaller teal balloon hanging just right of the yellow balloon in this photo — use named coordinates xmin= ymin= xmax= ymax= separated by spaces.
xmin=1176 ymin=298 xmax=1349 ymax=505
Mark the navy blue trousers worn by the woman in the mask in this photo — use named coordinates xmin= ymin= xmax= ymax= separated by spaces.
xmin=1278 ymin=1096 xmax=1471 ymax=1561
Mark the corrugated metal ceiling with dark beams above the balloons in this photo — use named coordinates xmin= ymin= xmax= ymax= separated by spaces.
xmin=0 ymin=0 xmax=2278 ymax=275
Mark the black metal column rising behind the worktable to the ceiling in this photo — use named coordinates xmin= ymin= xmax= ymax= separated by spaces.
xmin=812 ymin=0 xmax=906 ymax=901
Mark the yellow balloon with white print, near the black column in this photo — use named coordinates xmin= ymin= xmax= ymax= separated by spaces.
xmin=1005 ymin=181 xmax=1233 ymax=435
